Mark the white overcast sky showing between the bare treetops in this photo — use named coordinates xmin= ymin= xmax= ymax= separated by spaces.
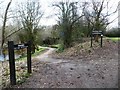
xmin=0 ymin=0 xmax=120 ymax=28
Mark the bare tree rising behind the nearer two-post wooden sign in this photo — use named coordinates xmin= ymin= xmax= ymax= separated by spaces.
xmin=18 ymin=1 xmax=43 ymax=53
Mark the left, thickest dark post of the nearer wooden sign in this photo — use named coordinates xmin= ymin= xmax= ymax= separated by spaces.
xmin=8 ymin=41 xmax=16 ymax=85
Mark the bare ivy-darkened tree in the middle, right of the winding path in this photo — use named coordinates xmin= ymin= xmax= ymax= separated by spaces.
xmin=53 ymin=2 xmax=83 ymax=48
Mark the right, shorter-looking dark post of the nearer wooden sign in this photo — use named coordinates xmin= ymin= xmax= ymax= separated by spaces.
xmin=27 ymin=41 xmax=32 ymax=73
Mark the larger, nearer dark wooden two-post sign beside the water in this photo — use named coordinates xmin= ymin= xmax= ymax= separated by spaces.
xmin=8 ymin=41 xmax=32 ymax=85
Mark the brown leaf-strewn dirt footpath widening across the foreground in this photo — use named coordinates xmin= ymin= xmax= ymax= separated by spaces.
xmin=11 ymin=40 xmax=118 ymax=88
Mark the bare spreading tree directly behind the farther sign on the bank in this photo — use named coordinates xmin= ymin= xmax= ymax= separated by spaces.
xmin=83 ymin=0 xmax=117 ymax=41
